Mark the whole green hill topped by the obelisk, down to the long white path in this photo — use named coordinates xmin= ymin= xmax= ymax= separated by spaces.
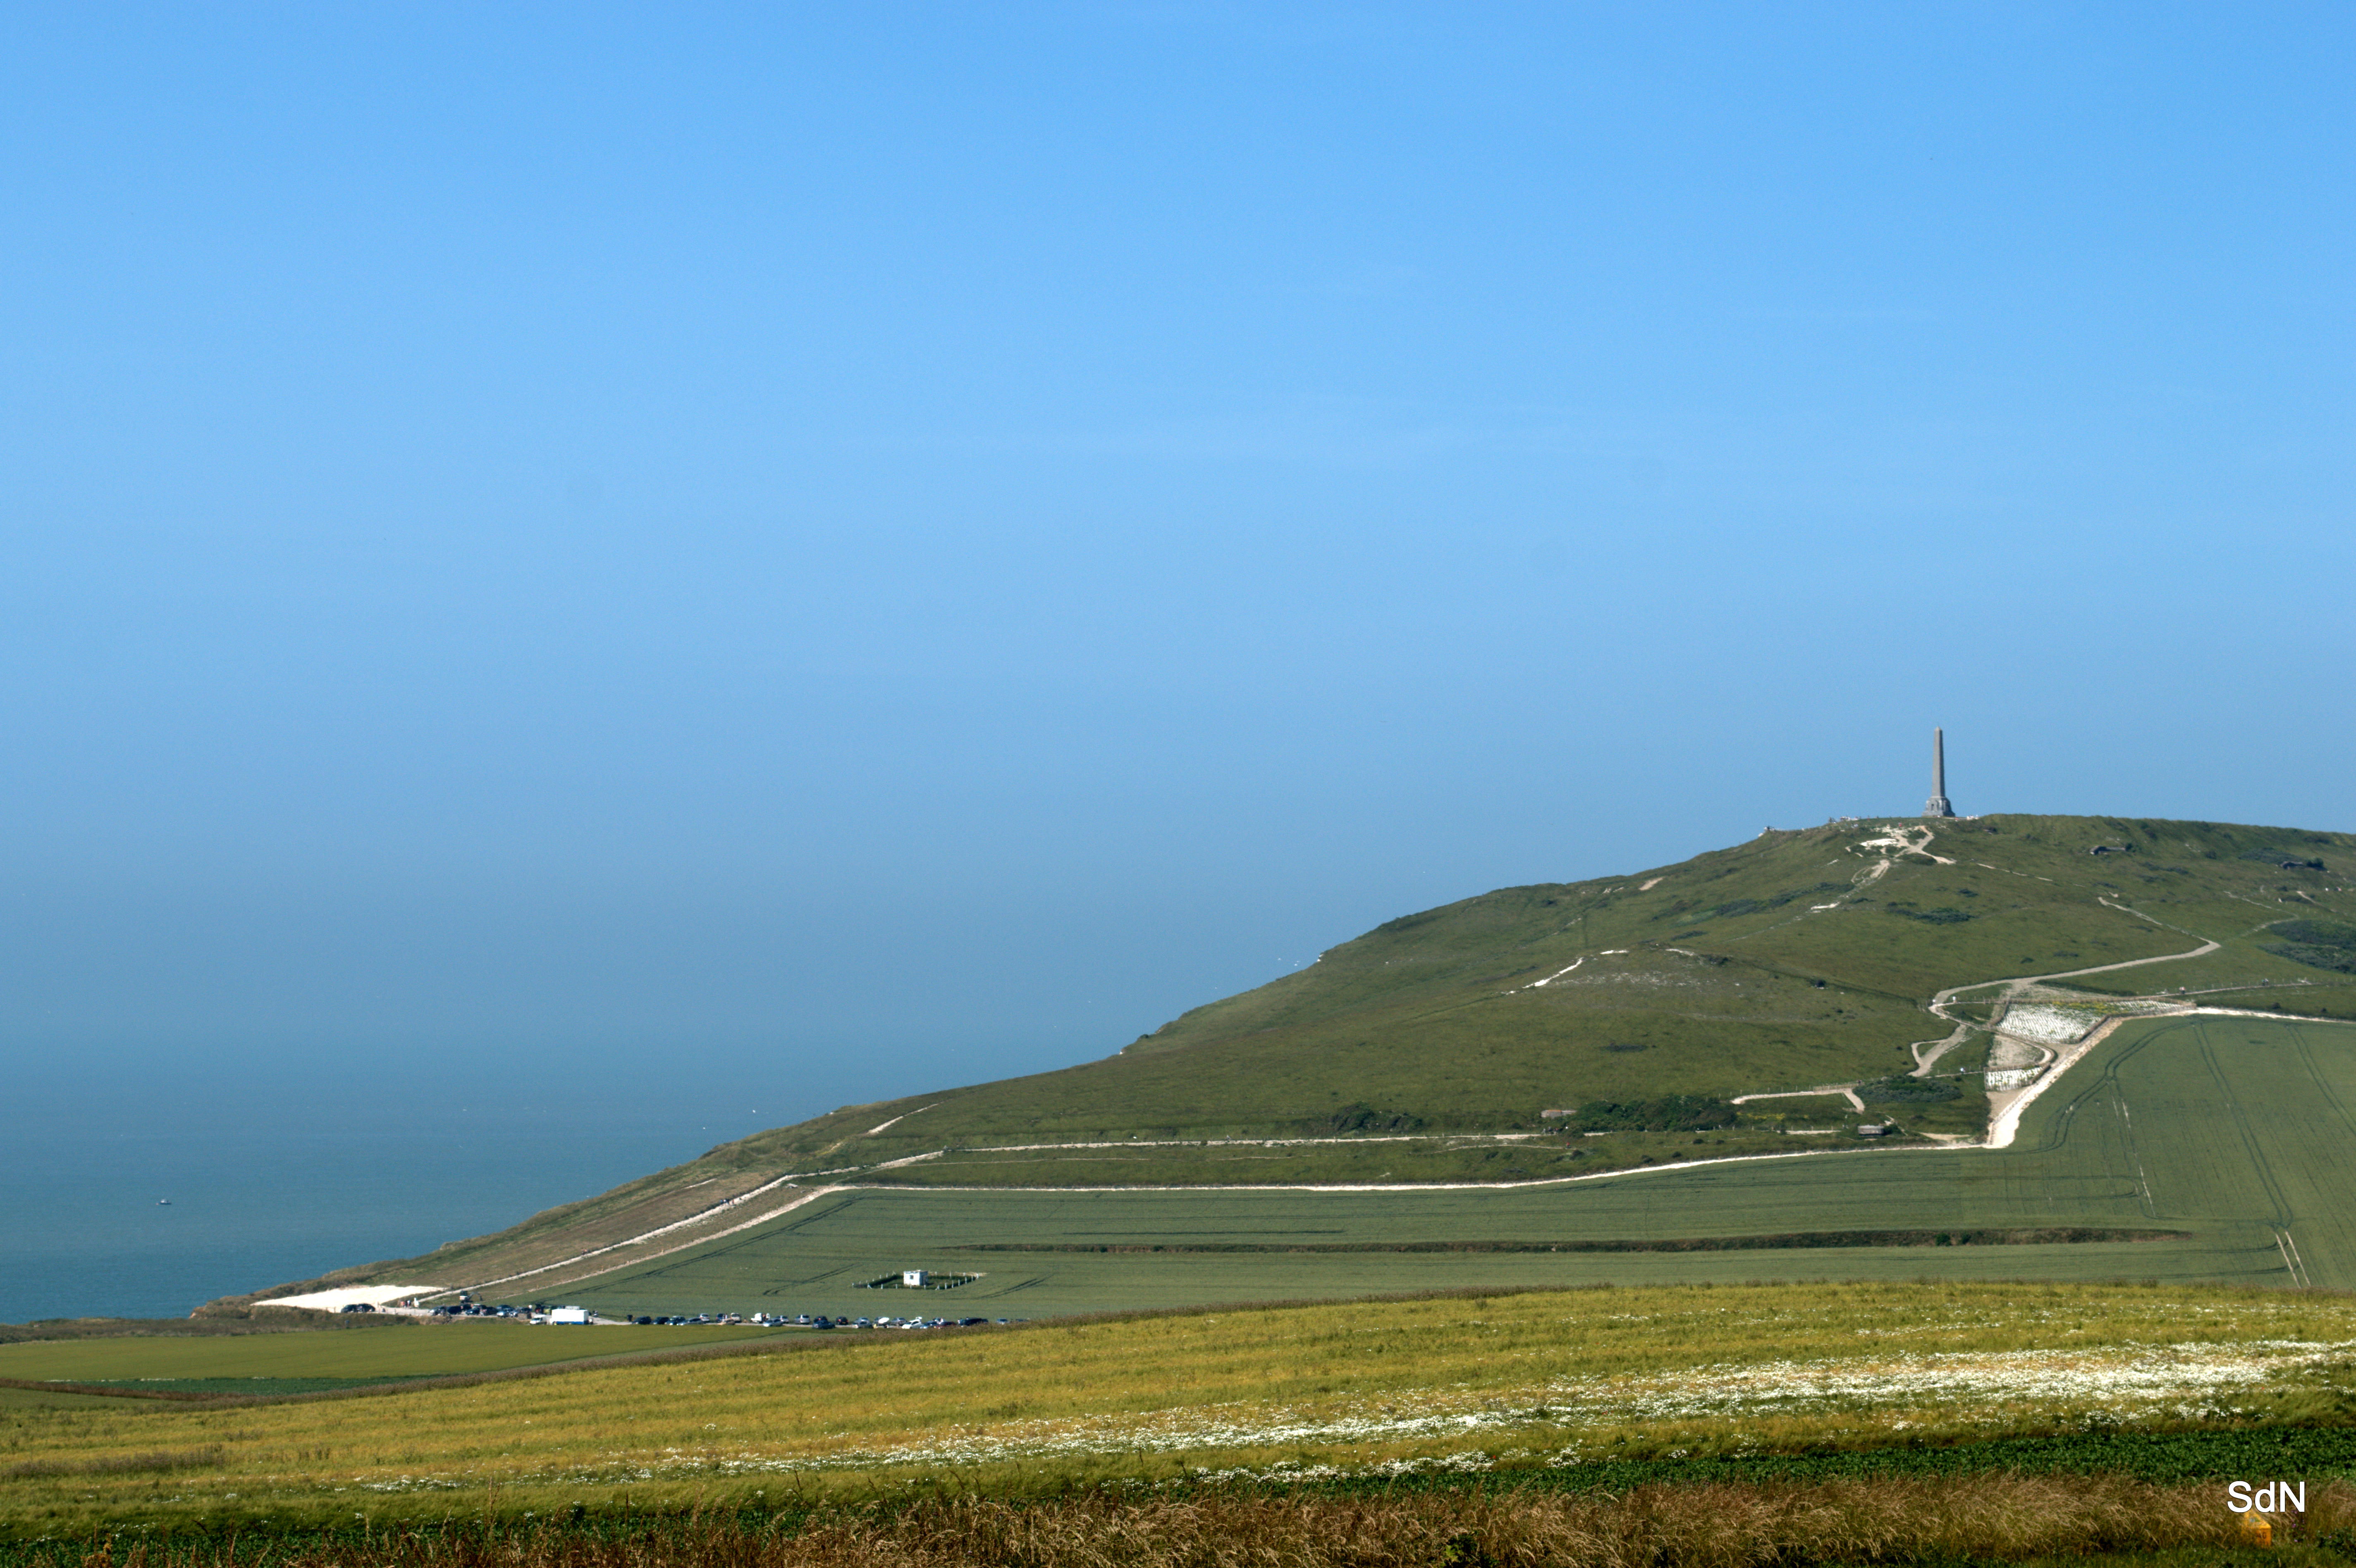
xmin=229 ymin=817 xmax=2356 ymax=1293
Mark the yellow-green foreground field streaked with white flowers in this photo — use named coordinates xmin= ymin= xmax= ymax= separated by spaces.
xmin=0 ymin=1283 xmax=2356 ymax=1535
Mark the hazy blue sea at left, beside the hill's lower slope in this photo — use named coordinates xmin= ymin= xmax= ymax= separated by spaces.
xmin=0 ymin=1050 xmax=777 ymax=1323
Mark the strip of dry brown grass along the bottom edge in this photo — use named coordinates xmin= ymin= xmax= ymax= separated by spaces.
xmin=57 ymin=1476 xmax=2356 ymax=1568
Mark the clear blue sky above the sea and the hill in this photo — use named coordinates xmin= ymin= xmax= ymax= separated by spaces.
xmin=0 ymin=0 xmax=2356 ymax=1123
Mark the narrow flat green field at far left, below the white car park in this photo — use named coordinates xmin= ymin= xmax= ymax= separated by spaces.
xmin=0 ymin=1321 xmax=791 ymax=1399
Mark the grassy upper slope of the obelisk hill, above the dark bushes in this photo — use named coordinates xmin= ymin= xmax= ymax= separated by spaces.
xmin=754 ymin=817 xmax=2356 ymax=1163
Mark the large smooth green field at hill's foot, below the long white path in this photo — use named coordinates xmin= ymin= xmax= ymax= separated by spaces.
xmin=542 ymin=1017 xmax=2356 ymax=1318
